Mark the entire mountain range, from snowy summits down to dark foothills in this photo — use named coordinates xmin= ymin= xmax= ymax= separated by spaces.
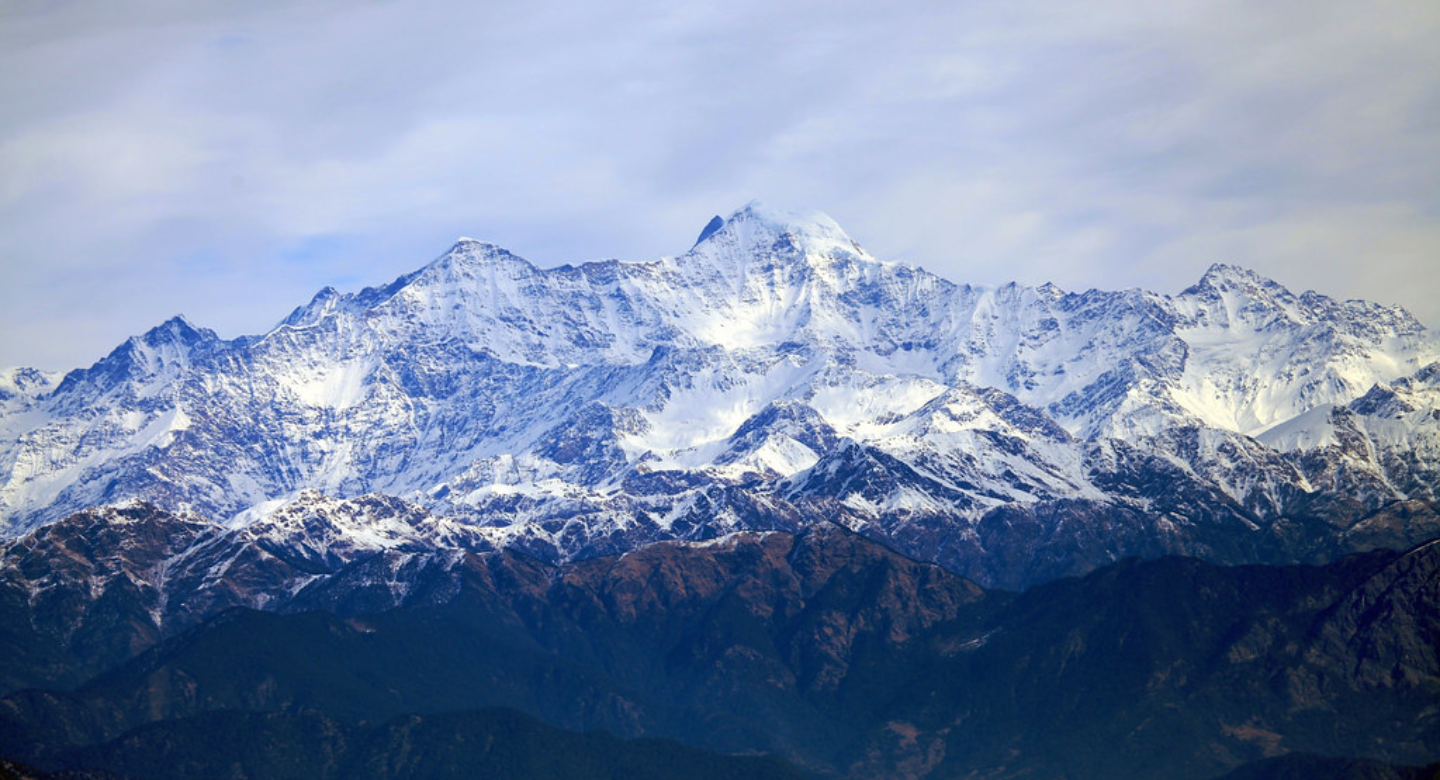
xmin=0 ymin=203 xmax=1440 ymax=780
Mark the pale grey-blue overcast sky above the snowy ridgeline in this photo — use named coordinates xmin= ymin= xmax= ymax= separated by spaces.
xmin=0 ymin=0 xmax=1440 ymax=368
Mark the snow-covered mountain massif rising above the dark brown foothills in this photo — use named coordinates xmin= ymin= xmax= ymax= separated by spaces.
xmin=0 ymin=203 xmax=1440 ymax=584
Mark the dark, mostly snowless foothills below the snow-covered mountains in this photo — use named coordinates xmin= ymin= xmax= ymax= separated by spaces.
xmin=0 ymin=527 xmax=1440 ymax=780
